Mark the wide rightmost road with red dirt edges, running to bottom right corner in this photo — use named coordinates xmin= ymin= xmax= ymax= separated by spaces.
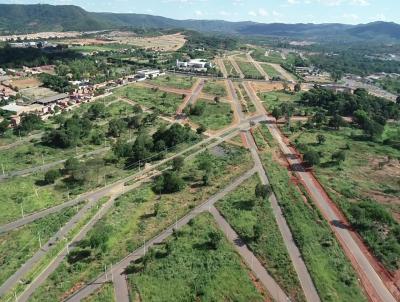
xmin=245 ymin=82 xmax=396 ymax=302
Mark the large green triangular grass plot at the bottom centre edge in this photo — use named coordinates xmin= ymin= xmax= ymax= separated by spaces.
xmin=129 ymin=214 xmax=264 ymax=302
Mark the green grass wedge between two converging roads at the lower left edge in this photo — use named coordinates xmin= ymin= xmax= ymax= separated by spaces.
xmin=0 ymin=205 xmax=81 ymax=284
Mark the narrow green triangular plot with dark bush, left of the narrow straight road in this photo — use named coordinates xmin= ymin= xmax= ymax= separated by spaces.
xmin=217 ymin=176 xmax=305 ymax=301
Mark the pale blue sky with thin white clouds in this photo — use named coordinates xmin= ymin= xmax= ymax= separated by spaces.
xmin=0 ymin=0 xmax=400 ymax=24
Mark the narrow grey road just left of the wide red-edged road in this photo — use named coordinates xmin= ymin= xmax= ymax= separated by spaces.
xmin=246 ymin=131 xmax=321 ymax=302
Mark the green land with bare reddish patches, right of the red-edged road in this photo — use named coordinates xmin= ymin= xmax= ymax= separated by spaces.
xmin=292 ymin=124 xmax=400 ymax=271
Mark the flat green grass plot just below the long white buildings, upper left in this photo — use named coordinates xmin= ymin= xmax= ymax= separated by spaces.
xmin=114 ymin=85 xmax=183 ymax=115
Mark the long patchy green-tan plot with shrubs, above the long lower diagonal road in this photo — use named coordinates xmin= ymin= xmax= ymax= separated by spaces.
xmin=31 ymin=144 xmax=252 ymax=301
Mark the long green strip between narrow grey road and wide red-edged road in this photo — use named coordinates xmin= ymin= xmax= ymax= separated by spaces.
xmin=261 ymin=125 xmax=367 ymax=302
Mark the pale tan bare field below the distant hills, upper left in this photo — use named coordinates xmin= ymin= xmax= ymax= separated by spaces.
xmin=112 ymin=33 xmax=186 ymax=51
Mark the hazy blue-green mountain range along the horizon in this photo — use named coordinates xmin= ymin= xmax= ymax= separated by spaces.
xmin=0 ymin=4 xmax=400 ymax=40
